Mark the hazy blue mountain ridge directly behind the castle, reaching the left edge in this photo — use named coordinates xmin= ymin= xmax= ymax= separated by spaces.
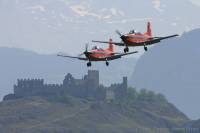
xmin=0 ymin=47 xmax=136 ymax=99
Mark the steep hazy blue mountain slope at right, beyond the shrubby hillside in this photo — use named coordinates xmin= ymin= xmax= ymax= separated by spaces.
xmin=132 ymin=29 xmax=200 ymax=119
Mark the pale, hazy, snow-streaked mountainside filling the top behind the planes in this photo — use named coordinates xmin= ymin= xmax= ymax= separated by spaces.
xmin=0 ymin=0 xmax=200 ymax=54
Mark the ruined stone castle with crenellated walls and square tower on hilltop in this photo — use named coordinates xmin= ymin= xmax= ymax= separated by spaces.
xmin=4 ymin=70 xmax=127 ymax=100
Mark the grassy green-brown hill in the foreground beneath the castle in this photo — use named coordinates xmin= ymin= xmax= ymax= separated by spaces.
xmin=0 ymin=93 xmax=189 ymax=133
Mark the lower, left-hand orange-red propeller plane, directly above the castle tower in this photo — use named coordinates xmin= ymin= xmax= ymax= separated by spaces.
xmin=57 ymin=39 xmax=137 ymax=67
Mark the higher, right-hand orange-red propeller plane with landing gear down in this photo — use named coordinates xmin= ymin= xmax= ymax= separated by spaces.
xmin=92 ymin=22 xmax=179 ymax=53
